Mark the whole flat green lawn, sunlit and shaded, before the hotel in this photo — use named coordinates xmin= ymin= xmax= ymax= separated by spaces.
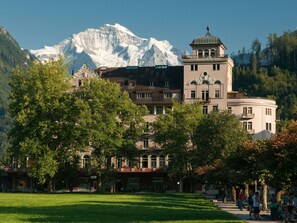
xmin=0 ymin=193 xmax=243 ymax=223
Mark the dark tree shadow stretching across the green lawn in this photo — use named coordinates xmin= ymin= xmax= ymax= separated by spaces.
xmin=0 ymin=195 xmax=242 ymax=223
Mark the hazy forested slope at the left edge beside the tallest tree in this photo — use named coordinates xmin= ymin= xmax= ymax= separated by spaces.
xmin=0 ymin=27 xmax=32 ymax=156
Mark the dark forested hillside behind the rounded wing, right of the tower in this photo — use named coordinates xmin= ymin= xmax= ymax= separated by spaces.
xmin=233 ymin=31 xmax=297 ymax=120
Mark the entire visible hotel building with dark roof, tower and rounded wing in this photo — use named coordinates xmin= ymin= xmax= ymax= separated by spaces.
xmin=3 ymin=29 xmax=277 ymax=192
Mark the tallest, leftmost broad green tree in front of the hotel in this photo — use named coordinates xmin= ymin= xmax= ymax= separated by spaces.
xmin=9 ymin=59 xmax=76 ymax=190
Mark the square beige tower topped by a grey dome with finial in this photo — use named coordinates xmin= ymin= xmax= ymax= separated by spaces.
xmin=183 ymin=27 xmax=233 ymax=113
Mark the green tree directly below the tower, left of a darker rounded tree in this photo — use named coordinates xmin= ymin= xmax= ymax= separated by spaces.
xmin=154 ymin=102 xmax=202 ymax=191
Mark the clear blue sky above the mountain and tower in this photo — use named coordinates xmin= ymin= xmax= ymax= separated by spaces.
xmin=0 ymin=0 xmax=297 ymax=54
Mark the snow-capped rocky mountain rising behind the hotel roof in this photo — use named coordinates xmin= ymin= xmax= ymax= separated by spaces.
xmin=30 ymin=24 xmax=182 ymax=71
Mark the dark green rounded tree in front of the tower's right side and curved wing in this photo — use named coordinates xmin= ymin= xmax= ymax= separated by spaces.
xmin=194 ymin=111 xmax=247 ymax=184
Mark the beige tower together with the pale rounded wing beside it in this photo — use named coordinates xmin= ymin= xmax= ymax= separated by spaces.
xmin=183 ymin=29 xmax=277 ymax=139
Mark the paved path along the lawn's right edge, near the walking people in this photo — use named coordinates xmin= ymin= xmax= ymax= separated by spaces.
xmin=214 ymin=201 xmax=280 ymax=223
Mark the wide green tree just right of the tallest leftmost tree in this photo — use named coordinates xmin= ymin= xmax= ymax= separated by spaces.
xmin=75 ymin=79 xmax=146 ymax=191
